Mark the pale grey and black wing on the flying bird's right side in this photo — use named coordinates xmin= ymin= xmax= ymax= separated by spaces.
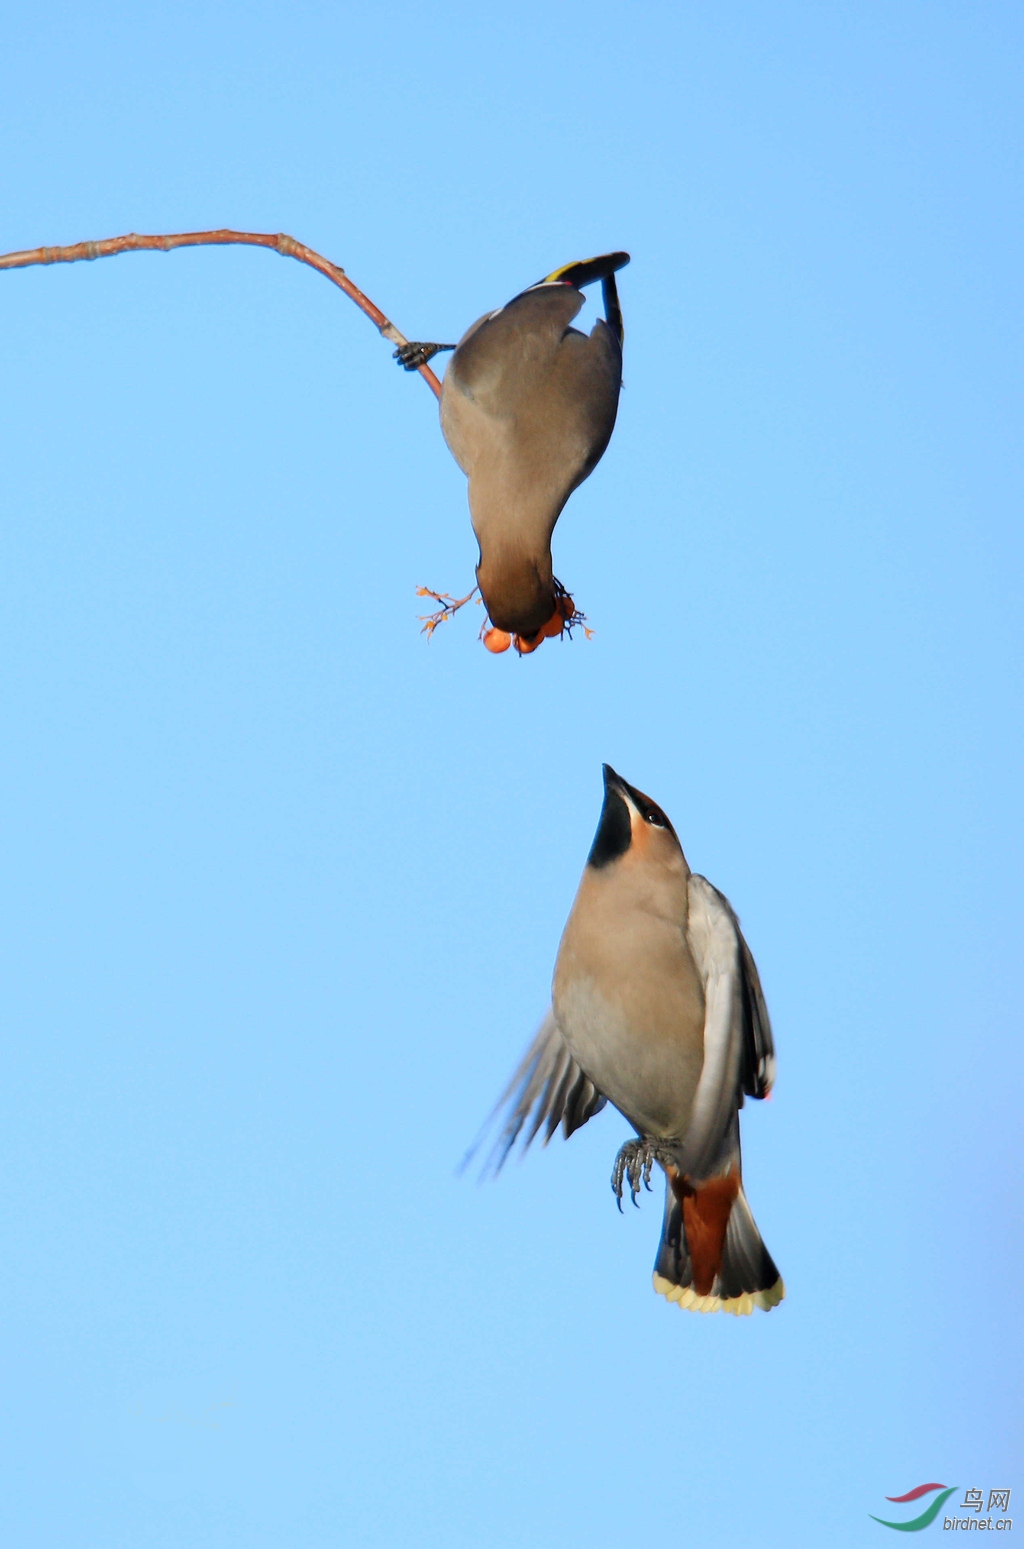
xmin=685 ymin=874 xmax=775 ymax=1179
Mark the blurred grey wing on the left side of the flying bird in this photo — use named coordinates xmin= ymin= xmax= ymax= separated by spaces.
xmin=466 ymin=1008 xmax=607 ymax=1173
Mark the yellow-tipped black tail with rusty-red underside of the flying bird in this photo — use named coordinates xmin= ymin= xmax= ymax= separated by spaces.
xmin=654 ymin=1173 xmax=785 ymax=1315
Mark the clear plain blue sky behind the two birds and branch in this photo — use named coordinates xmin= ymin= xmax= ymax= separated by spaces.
xmin=0 ymin=0 xmax=1024 ymax=1549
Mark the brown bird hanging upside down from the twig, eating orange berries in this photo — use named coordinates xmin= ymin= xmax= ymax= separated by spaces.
xmin=395 ymin=252 xmax=629 ymax=644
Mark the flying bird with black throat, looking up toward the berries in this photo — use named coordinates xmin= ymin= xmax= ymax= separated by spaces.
xmin=494 ymin=764 xmax=784 ymax=1314
